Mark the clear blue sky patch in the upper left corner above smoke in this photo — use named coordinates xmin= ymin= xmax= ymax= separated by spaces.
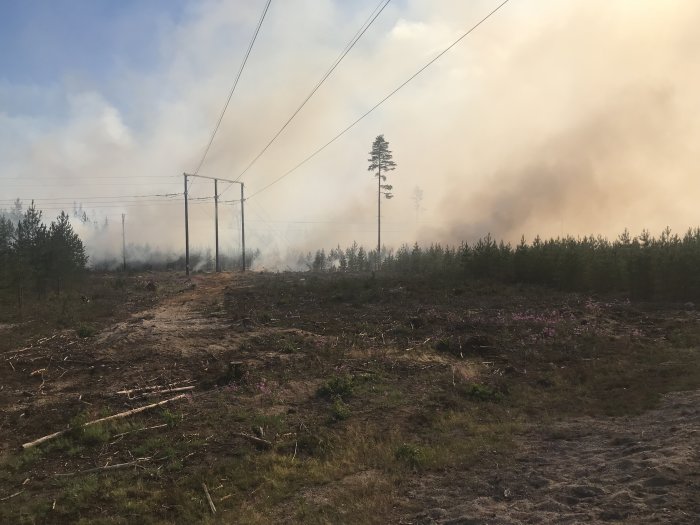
xmin=0 ymin=0 xmax=185 ymax=84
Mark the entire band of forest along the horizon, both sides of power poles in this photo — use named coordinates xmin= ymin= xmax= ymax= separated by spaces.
xmin=6 ymin=196 xmax=700 ymax=304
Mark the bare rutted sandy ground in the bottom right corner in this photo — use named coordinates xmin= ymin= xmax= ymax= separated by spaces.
xmin=411 ymin=391 xmax=700 ymax=525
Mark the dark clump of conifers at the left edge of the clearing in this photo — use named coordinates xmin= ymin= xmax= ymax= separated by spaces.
xmin=0 ymin=202 xmax=88 ymax=306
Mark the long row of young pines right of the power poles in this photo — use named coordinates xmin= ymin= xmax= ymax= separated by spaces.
xmin=300 ymin=228 xmax=700 ymax=300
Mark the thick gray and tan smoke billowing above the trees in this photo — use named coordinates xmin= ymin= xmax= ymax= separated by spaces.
xmin=5 ymin=0 xmax=700 ymax=268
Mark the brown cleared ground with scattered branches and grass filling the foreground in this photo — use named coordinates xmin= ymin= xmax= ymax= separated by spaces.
xmin=0 ymin=273 xmax=700 ymax=524
